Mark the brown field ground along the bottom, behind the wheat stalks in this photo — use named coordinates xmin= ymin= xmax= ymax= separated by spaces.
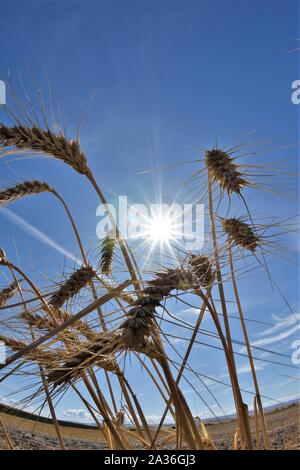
xmin=0 ymin=404 xmax=300 ymax=450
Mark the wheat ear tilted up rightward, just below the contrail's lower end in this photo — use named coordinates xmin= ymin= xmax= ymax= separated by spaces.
xmin=49 ymin=266 xmax=96 ymax=309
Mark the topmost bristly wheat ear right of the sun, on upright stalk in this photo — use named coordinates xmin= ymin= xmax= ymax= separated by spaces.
xmin=205 ymin=149 xmax=251 ymax=194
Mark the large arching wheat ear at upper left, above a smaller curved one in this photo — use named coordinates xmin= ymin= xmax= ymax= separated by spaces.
xmin=0 ymin=124 xmax=90 ymax=175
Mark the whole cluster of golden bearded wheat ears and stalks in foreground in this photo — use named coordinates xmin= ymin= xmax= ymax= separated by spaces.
xmin=0 ymin=79 xmax=294 ymax=450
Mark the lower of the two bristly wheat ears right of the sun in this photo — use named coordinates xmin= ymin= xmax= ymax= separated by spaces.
xmin=222 ymin=219 xmax=260 ymax=252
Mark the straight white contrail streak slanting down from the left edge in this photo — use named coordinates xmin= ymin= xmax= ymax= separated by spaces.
xmin=0 ymin=207 xmax=82 ymax=266
